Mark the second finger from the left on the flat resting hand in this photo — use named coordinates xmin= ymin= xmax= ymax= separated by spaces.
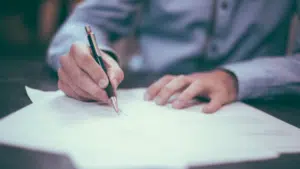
xmin=155 ymin=75 xmax=189 ymax=105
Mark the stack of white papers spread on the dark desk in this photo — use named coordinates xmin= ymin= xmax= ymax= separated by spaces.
xmin=0 ymin=88 xmax=300 ymax=168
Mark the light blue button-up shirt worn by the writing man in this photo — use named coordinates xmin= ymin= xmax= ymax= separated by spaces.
xmin=47 ymin=0 xmax=300 ymax=99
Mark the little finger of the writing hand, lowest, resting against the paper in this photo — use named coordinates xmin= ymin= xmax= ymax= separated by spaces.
xmin=57 ymin=68 xmax=97 ymax=101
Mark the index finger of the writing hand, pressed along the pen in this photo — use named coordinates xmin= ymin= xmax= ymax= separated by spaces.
xmin=70 ymin=42 xmax=108 ymax=88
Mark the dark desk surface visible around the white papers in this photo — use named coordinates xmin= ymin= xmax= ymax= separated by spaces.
xmin=0 ymin=61 xmax=300 ymax=169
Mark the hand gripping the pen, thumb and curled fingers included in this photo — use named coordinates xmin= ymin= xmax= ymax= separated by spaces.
xmin=58 ymin=43 xmax=124 ymax=103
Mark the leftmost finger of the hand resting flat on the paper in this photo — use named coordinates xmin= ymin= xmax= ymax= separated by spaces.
xmin=144 ymin=75 xmax=174 ymax=100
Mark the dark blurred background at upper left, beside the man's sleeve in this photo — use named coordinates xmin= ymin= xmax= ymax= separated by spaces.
xmin=0 ymin=0 xmax=76 ymax=60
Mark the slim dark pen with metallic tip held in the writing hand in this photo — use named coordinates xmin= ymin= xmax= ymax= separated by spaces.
xmin=85 ymin=26 xmax=119 ymax=113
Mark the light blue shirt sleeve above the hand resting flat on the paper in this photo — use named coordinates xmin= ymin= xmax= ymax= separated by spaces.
xmin=223 ymin=55 xmax=300 ymax=100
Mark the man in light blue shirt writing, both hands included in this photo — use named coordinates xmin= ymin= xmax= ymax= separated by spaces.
xmin=48 ymin=0 xmax=300 ymax=113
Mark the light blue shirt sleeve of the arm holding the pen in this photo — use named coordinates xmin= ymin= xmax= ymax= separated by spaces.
xmin=47 ymin=0 xmax=139 ymax=70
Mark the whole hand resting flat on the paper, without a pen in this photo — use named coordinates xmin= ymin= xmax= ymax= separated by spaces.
xmin=145 ymin=70 xmax=237 ymax=113
